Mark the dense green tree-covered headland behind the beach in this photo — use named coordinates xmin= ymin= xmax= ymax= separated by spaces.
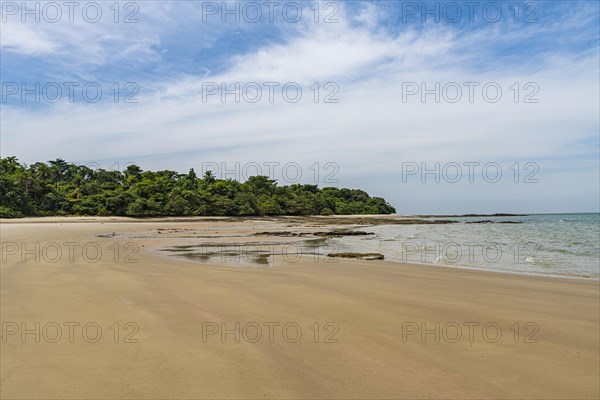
xmin=0 ymin=157 xmax=395 ymax=218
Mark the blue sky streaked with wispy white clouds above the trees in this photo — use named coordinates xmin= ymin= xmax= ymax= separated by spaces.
xmin=0 ymin=1 xmax=600 ymax=214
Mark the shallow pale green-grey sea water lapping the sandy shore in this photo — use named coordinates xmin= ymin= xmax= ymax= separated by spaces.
xmin=331 ymin=213 xmax=600 ymax=279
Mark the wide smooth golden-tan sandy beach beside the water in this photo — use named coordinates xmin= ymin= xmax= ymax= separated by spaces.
xmin=0 ymin=217 xmax=600 ymax=399
